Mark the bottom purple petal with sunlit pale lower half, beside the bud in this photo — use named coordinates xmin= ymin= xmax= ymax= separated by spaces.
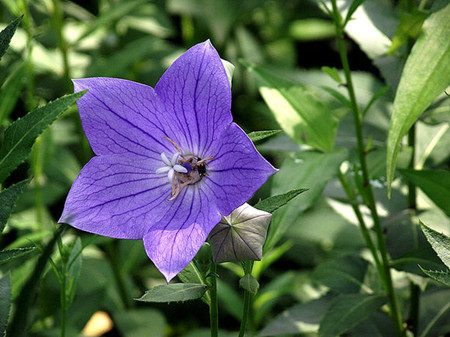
xmin=144 ymin=185 xmax=222 ymax=282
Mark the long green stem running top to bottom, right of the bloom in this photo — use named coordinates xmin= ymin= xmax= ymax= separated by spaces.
xmin=331 ymin=0 xmax=405 ymax=336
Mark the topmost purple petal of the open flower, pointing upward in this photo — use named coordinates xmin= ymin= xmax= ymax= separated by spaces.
xmin=155 ymin=40 xmax=232 ymax=158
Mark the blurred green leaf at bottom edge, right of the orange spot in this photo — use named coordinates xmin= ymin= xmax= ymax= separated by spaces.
xmin=113 ymin=308 xmax=166 ymax=337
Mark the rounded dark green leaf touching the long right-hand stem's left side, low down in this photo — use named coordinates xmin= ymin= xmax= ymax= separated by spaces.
xmin=313 ymin=255 xmax=372 ymax=293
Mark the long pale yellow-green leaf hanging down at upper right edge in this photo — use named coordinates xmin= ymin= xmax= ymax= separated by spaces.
xmin=386 ymin=4 xmax=450 ymax=195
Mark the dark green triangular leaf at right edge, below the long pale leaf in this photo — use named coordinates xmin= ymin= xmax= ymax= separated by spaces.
xmin=398 ymin=169 xmax=450 ymax=216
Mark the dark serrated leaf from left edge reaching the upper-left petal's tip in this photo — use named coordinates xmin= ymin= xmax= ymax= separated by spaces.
xmin=0 ymin=91 xmax=86 ymax=183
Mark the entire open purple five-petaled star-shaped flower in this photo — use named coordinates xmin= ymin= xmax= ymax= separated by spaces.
xmin=59 ymin=41 xmax=276 ymax=281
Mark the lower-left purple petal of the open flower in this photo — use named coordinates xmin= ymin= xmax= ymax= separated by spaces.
xmin=59 ymin=155 xmax=171 ymax=239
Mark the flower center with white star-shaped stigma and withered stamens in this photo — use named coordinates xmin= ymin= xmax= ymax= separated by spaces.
xmin=156 ymin=137 xmax=214 ymax=201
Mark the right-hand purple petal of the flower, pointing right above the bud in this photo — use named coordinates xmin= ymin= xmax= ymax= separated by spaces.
xmin=203 ymin=123 xmax=277 ymax=215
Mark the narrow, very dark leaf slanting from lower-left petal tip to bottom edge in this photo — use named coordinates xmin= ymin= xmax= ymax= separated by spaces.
xmin=6 ymin=225 xmax=65 ymax=337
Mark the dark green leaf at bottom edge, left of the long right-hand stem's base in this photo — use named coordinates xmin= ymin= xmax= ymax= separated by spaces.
xmin=319 ymin=294 xmax=387 ymax=337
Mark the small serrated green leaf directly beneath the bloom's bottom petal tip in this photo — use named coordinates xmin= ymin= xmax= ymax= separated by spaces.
xmin=136 ymin=283 xmax=208 ymax=303
